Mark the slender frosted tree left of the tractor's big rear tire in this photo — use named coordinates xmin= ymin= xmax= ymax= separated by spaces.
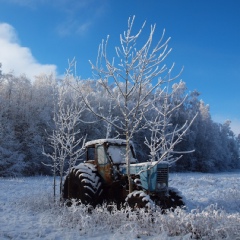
xmin=43 ymin=71 xmax=86 ymax=198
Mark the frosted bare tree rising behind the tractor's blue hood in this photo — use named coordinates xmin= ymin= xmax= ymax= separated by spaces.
xmin=144 ymin=84 xmax=197 ymax=166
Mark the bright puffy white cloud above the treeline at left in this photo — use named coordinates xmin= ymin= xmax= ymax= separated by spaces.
xmin=0 ymin=23 xmax=57 ymax=79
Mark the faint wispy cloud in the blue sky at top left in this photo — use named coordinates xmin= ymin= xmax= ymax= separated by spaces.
xmin=3 ymin=0 xmax=109 ymax=37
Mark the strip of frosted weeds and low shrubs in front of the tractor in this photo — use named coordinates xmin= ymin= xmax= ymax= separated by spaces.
xmin=21 ymin=190 xmax=240 ymax=239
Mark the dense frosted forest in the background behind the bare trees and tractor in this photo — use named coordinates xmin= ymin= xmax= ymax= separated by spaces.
xmin=0 ymin=69 xmax=240 ymax=176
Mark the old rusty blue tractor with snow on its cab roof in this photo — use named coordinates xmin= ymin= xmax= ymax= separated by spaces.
xmin=62 ymin=139 xmax=184 ymax=209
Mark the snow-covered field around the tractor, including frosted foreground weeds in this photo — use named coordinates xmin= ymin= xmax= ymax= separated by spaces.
xmin=0 ymin=171 xmax=240 ymax=240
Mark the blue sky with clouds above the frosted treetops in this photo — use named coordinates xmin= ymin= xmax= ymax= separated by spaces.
xmin=0 ymin=0 xmax=240 ymax=133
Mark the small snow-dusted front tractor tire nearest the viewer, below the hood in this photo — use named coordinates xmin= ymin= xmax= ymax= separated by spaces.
xmin=126 ymin=190 xmax=154 ymax=209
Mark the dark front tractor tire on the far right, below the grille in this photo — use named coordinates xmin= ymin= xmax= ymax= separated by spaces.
xmin=166 ymin=188 xmax=185 ymax=209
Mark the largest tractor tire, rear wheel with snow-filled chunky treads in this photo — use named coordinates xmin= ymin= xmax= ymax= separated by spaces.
xmin=62 ymin=163 xmax=102 ymax=206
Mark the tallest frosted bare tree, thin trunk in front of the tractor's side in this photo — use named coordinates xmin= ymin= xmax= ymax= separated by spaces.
xmin=74 ymin=17 xmax=183 ymax=192
